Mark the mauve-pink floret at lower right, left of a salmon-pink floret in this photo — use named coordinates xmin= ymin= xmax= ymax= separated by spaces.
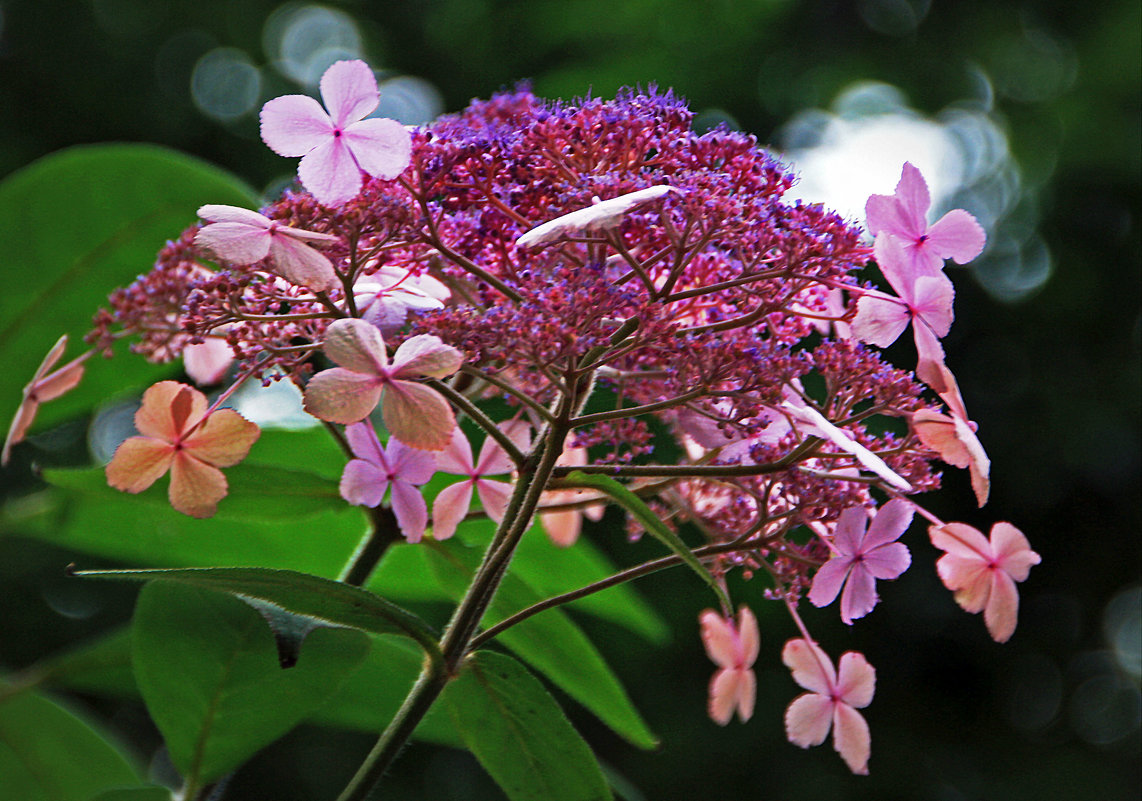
xmin=809 ymin=498 xmax=912 ymax=625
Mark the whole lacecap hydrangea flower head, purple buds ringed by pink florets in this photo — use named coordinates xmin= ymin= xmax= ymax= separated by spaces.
xmin=5 ymin=62 xmax=1039 ymax=774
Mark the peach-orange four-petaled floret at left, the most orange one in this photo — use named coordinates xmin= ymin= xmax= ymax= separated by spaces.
xmin=106 ymin=381 xmax=262 ymax=518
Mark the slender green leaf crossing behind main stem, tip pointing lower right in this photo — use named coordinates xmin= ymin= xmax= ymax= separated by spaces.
xmin=428 ymin=540 xmax=658 ymax=748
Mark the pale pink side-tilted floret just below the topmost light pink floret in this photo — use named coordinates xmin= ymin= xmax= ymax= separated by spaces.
xmin=194 ymin=206 xmax=338 ymax=291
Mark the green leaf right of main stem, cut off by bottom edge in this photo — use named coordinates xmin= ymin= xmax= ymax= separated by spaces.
xmin=441 ymin=651 xmax=611 ymax=801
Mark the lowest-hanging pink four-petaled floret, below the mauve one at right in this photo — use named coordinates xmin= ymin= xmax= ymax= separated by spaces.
xmin=781 ymin=639 xmax=876 ymax=776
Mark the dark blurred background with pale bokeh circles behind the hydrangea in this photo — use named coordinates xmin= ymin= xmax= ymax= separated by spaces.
xmin=0 ymin=0 xmax=1142 ymax=801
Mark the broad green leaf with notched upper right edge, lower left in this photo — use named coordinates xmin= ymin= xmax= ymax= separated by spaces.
xmin=132 ymin=582 xmax=367 ymax=794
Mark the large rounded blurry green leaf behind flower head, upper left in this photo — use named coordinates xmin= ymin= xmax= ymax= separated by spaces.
xmin=0 ymin=144 xmax=257 ymax=431
